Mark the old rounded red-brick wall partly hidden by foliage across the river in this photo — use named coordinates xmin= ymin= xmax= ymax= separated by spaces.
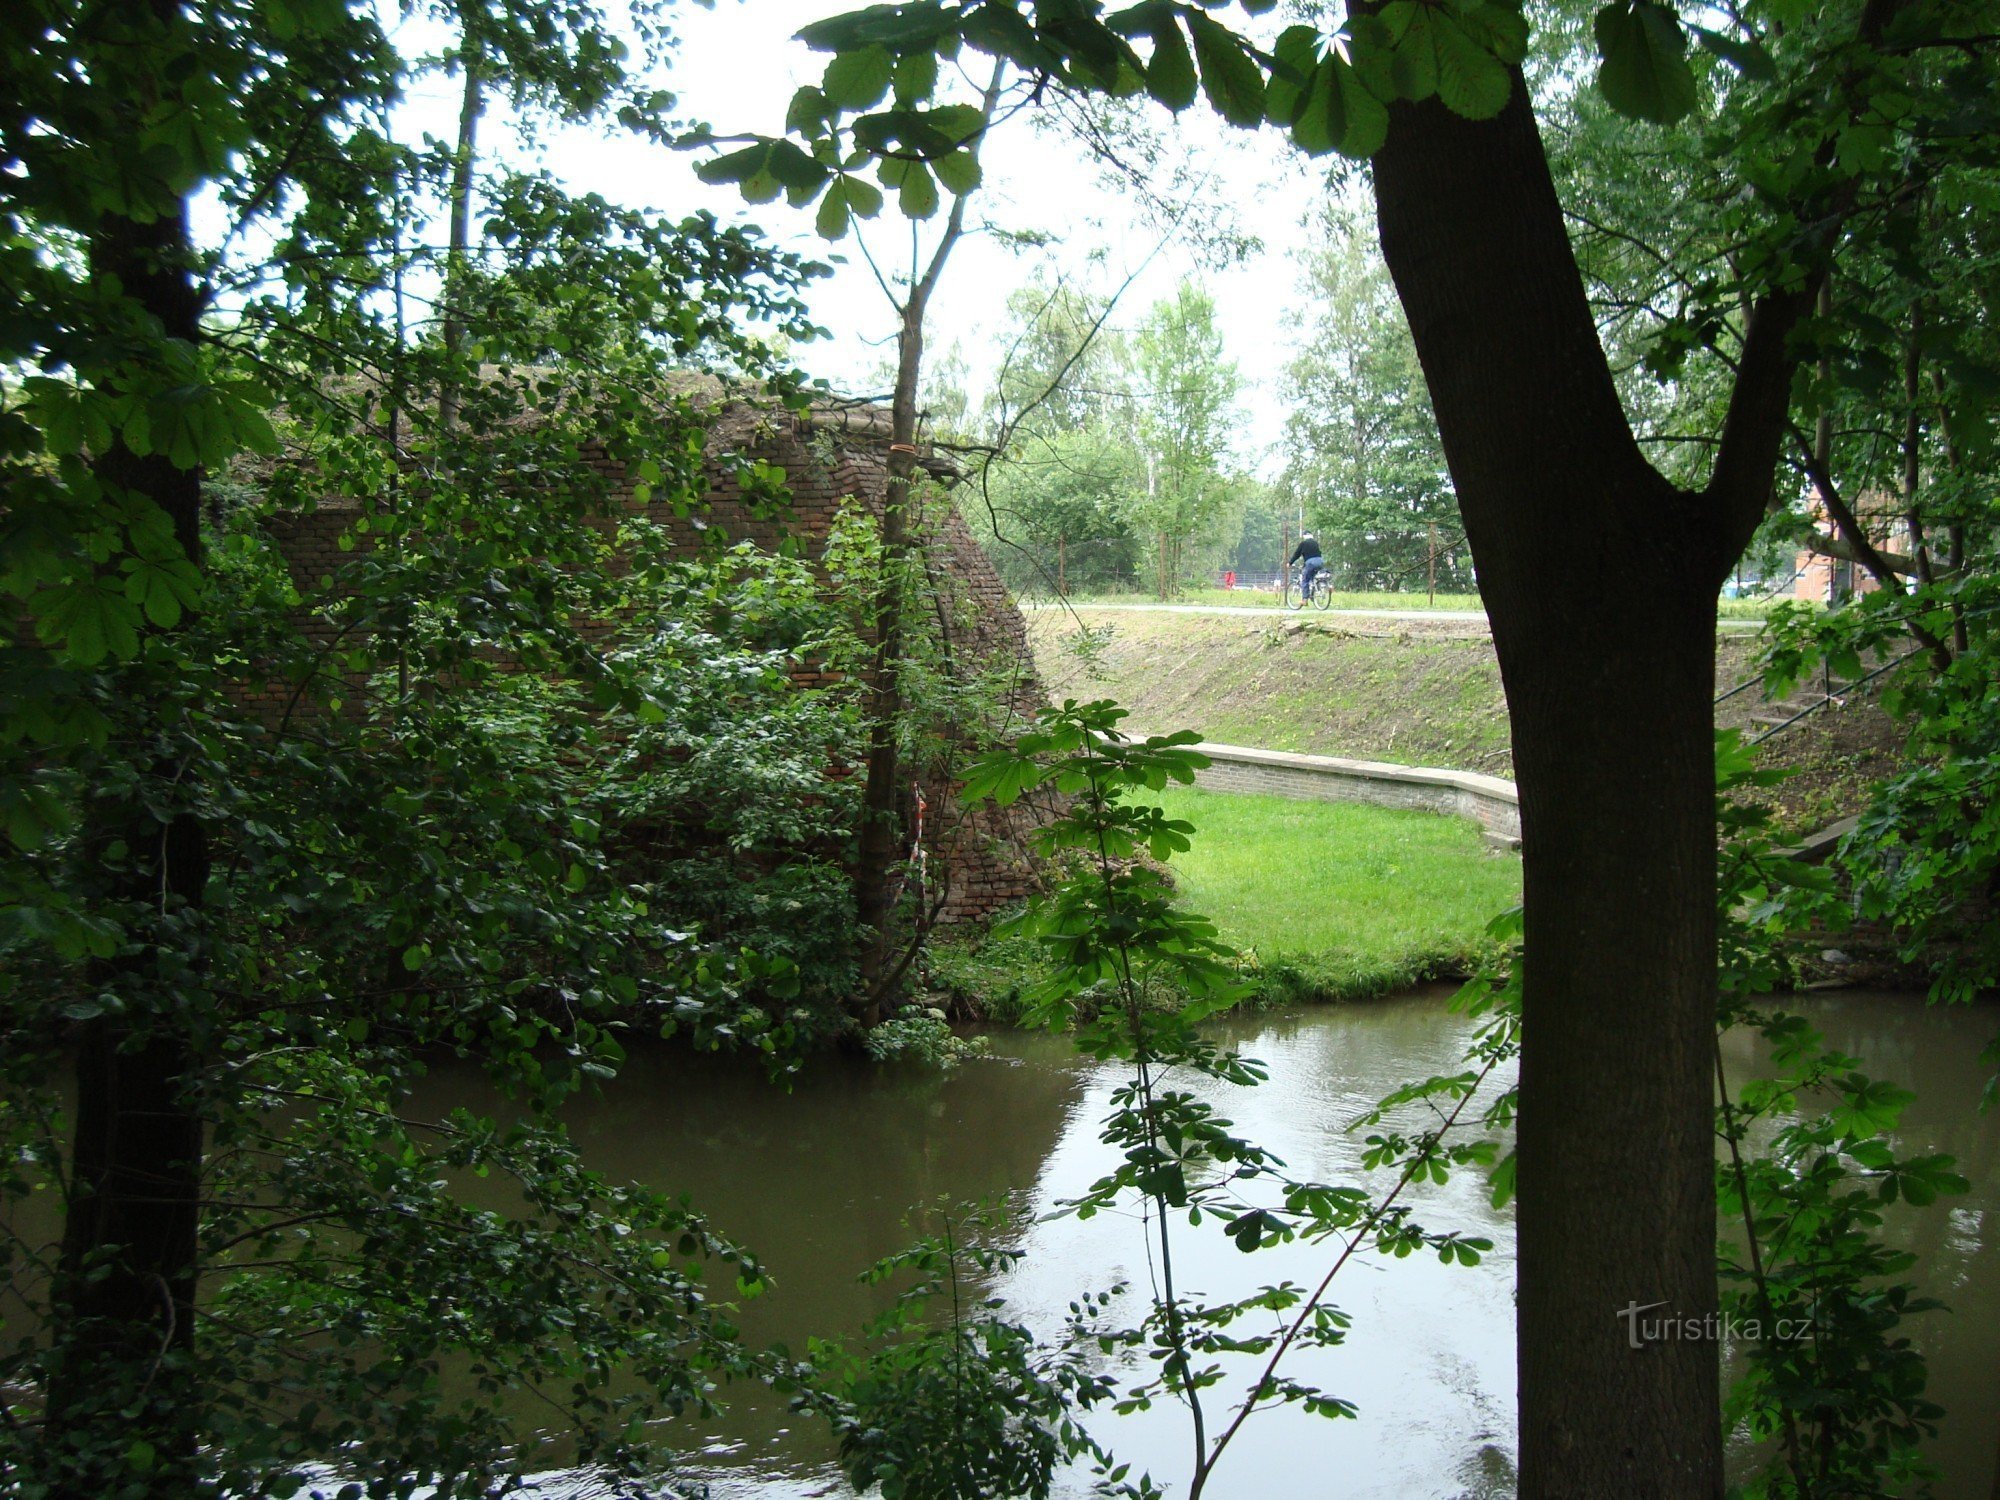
xmin=254 ymin=402 xmax=1046 ymax=924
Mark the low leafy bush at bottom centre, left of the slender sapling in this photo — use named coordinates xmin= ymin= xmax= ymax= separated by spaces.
xmin=798 ymin=1208 xmax=1122 ymax=1500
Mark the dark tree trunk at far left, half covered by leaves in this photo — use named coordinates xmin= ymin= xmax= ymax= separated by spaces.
xmin=46 ymin=185 xmax=208 ymax=1500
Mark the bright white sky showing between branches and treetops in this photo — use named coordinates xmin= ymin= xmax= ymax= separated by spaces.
xmin=382 ymin=0 xmax=1352 ymax=476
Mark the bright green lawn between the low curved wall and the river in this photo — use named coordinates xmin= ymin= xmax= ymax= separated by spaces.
xmin=930 ymin=788 xmax=1520 ymax=1020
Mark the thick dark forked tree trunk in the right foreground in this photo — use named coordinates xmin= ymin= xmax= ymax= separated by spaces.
xmin=1374 ymin=76 xmax=1736 ymax=1500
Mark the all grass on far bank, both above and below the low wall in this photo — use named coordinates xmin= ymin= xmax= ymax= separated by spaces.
xmin=926 ymin=610 xmax=1898 ymax=1020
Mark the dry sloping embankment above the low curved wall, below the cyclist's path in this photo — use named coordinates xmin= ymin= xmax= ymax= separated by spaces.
xmin=1028 ymin=608 xmax=1902 ymax=848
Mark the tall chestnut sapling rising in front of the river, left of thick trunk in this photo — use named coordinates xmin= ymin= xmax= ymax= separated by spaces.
xmin=966 ymin=700 xmax=1514 ymax=1496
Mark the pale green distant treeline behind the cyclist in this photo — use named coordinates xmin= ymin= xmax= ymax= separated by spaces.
xmin=960 ymin=216 xmax=1472 ymax=598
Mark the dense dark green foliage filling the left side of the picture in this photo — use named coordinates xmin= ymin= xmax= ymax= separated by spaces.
xmin=0 ymin=4 xmax=844 ymax=1496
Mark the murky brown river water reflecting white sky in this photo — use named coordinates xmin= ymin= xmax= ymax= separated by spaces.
xmin=410 ymin=994 xmax=2000 ymax=1500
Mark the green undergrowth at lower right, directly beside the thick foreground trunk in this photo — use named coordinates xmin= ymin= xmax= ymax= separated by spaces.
xmin=1716 ymin=732 xmax=1968 ymax=1500
